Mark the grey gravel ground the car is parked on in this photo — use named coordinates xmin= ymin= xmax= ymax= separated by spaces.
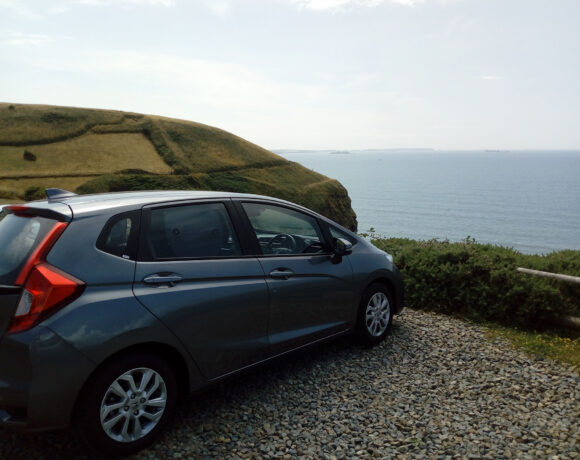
xmin=0 ymin=309 xmax=580 ymax=459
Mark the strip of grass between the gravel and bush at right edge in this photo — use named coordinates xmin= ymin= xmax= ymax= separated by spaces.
xmin=486 ymin=323 xmax=580 ymax=369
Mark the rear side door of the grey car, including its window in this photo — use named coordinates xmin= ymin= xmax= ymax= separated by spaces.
xmin=134 ymin=201 xmax=268 ymax=379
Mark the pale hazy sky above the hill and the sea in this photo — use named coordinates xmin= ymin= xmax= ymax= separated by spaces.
xmin=0 ymin=0 xmax=580 ymax=150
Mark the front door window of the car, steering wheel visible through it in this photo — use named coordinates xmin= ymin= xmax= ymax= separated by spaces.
xmin=243 ymin=203 xmax=325 ymax=255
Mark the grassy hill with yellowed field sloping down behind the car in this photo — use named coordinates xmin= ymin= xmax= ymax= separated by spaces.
xmin=0 ymin=103 xmax=357 ymax=230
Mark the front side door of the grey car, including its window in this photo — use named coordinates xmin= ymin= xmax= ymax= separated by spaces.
xmin=236 ymin=202 xmax=356 ymax=354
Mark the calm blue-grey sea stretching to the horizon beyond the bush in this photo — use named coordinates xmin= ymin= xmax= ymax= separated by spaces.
xmin=275 ymin=149 xmax=580 ymax=254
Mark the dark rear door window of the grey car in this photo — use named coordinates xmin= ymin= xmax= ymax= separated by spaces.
xmin=144 ymin=203 xmax=242 ymax=260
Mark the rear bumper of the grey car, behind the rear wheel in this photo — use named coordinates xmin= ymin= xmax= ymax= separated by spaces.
xmin=0 ymin=326 xmax=94 ymax=431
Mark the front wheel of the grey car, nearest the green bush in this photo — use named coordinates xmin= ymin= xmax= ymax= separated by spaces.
xmin=358 ymin=283 xmax=393 ymax=345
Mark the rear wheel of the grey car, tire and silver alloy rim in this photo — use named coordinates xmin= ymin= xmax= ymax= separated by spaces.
xmin=73 ymin=353 xmax=177 ymax=456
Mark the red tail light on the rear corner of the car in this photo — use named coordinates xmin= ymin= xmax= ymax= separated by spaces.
xmin=7 ymin=222 xmax=85 ymax=333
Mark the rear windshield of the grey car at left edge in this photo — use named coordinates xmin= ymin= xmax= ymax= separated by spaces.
xmin=0 ymin=212 xmax=55 ymax=285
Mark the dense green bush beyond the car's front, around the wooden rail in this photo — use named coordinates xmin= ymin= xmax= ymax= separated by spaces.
xmin=372 ymin=238 xmax=580 ymax=329
